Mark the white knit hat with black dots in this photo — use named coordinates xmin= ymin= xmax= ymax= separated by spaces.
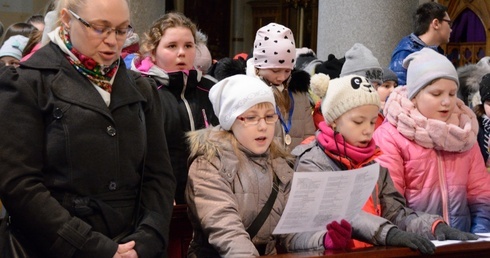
xmin=253 ymin=23 xmax=296 ymax=69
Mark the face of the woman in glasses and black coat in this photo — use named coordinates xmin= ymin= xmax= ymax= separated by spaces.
xmin=61 ymin=0 xmax=129 ymax=65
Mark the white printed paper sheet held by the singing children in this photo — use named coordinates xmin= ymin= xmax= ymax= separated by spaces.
xmin=273 ymin=163 xmax=379 ymax=234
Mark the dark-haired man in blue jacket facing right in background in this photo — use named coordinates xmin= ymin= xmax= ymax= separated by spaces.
xmin=389 ymin=2 xmax=452 ymax=85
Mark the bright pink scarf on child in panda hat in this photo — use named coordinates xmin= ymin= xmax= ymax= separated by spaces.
xmin=316 ymin=121 xmax=381 ymax=169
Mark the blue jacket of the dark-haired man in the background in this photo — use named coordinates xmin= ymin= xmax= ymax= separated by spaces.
xmin=390 ymin=33 xmax=443 ymax=85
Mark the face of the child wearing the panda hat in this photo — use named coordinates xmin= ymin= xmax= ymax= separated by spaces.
xmin=332 ymin=105 xmax=379 ymax=147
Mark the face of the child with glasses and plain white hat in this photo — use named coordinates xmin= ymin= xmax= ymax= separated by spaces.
xmin=231 ymin=103 xmax=277 ymax=155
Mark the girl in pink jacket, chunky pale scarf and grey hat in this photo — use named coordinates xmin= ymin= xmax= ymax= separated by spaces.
xmin=374 ymin=48 xmax=490 ymax=233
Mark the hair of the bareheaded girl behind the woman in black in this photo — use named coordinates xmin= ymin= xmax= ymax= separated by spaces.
xmin=140 ymin=12 xmax=197 ymax=56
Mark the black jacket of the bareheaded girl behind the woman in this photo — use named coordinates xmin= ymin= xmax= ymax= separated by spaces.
xmin=149 ymin=70 xmax=219 ymax=204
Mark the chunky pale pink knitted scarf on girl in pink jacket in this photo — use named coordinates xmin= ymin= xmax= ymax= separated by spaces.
xmin=383 ymin=87 xmax=478 ymax=152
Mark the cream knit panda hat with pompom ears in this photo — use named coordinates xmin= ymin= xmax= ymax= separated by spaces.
xmin=310 ymin=73 xmax=381 ymax=124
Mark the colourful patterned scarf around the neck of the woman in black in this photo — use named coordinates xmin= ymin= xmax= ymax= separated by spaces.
xmin=59 ymin=28 xmax=119 ymax=93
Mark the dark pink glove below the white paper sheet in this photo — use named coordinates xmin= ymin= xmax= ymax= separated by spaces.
xmin=323 ymin=220 xmax=352 ymax=249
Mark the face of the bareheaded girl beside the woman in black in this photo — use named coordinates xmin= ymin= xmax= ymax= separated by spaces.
xmin=153 ymin=27 xmax=196 ymax=72
